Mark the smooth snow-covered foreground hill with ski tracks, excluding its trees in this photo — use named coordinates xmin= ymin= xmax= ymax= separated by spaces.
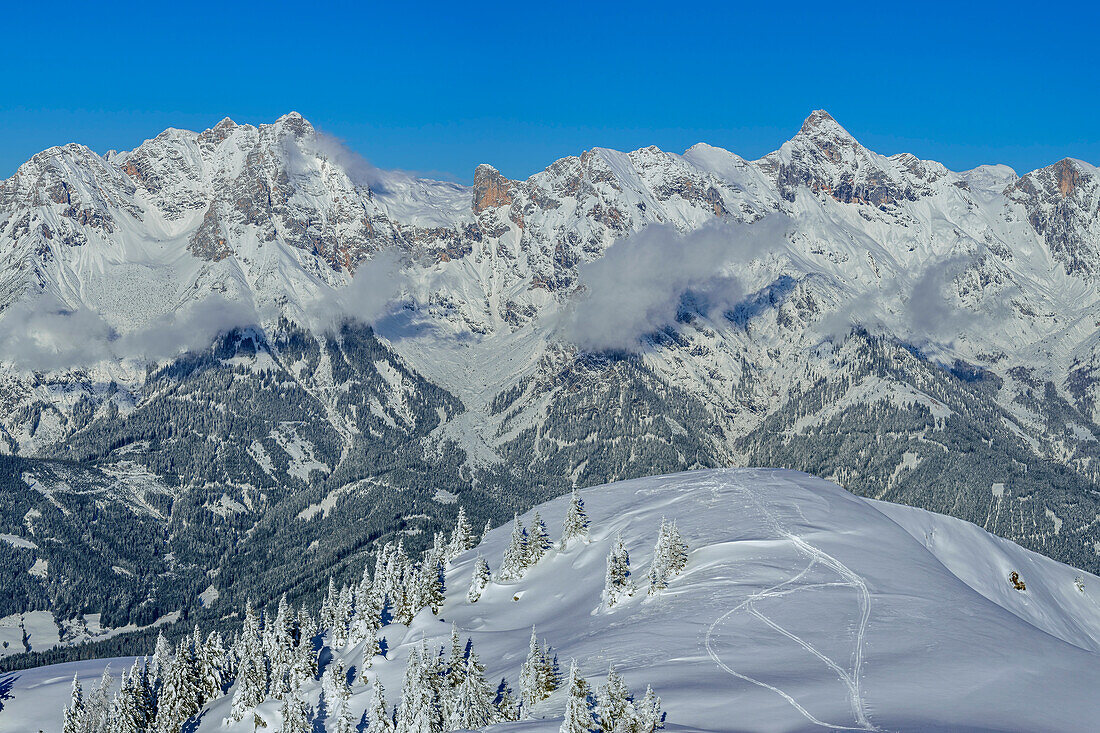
xmin=8 ymin=469 xmax=1100 ymax=732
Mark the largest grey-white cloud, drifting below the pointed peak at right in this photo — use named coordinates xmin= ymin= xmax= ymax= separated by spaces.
xmin=562 ymin=215 xmax=790 ymax=351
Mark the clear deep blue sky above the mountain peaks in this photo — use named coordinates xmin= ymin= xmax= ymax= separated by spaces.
xmin=0 ymin=0 xmax=1100 ymax=180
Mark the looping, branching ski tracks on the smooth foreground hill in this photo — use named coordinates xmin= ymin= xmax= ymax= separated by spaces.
xmin=705 ymin=471 xmax=882 ymax=731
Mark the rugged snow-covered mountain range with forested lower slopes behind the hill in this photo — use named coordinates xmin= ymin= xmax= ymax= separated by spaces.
xmin=0 ymin=111 xmax=1100 ymax=651
